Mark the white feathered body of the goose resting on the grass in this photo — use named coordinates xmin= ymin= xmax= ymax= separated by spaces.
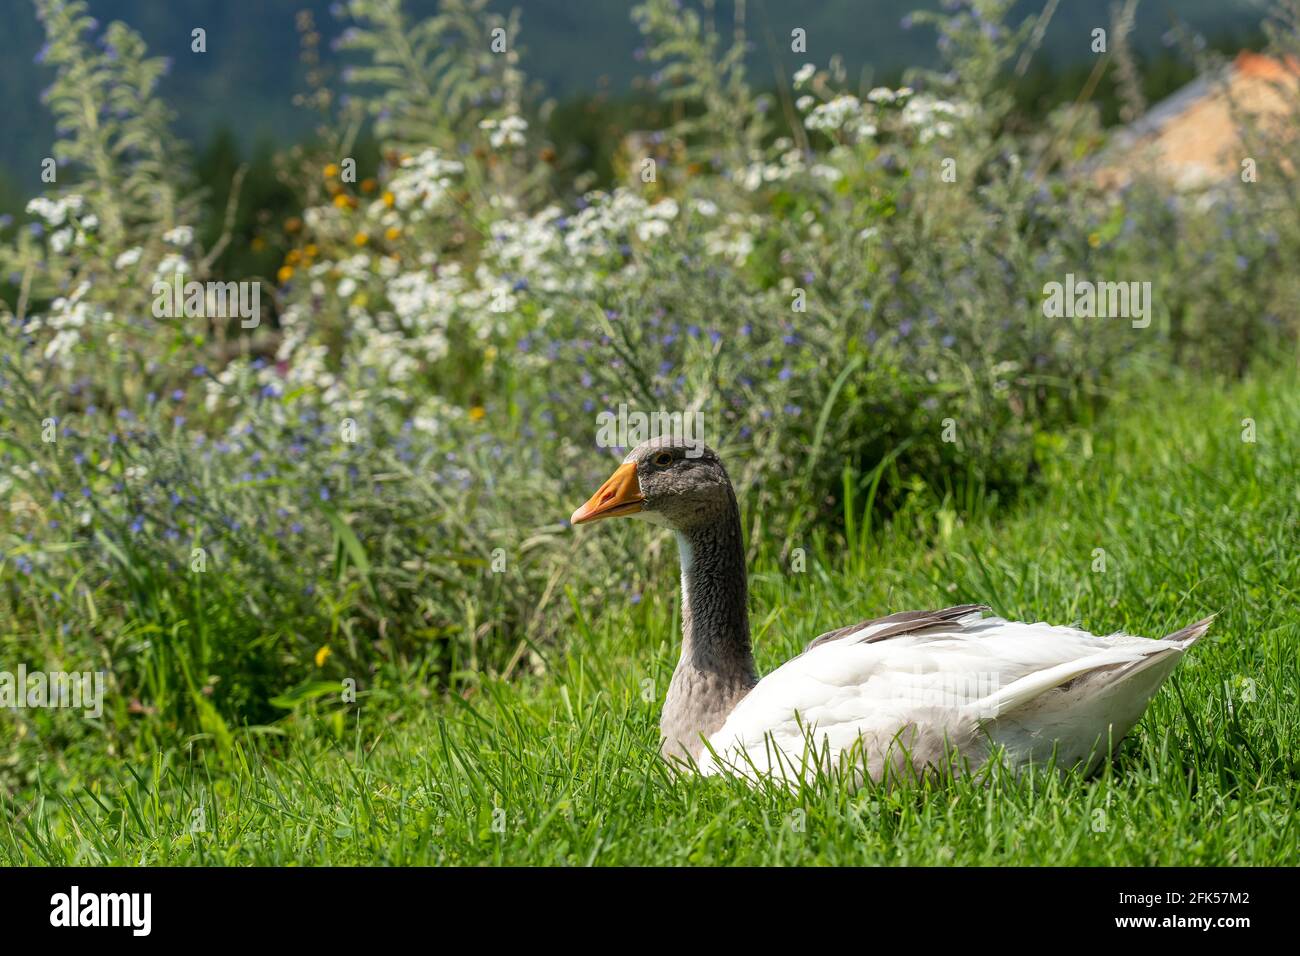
xmin=698 ymin=611 xmax=1209 ymax=783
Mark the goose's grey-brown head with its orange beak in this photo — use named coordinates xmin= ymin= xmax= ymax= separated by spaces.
xmin=569 ymin=438 xmax=736 ymax=533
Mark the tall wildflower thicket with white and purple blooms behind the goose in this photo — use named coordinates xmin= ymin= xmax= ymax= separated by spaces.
xmin=0 ymin=0 xmax=1300 ymax=736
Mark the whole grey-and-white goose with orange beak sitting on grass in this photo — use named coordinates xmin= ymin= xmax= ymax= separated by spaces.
xmin=569 ymin=437 xmax=1213 ymax=786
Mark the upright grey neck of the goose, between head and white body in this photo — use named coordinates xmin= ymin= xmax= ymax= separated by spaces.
xmin=659 ymin=497 xmax=758 ymax=760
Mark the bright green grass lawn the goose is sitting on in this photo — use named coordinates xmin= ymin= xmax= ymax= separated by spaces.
xmin=0 ymin=372 xmax=1300 ymax=865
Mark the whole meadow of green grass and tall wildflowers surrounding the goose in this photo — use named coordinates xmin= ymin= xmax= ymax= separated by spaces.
xmin=0 ymin=0 xmax=1300 ymax=865
